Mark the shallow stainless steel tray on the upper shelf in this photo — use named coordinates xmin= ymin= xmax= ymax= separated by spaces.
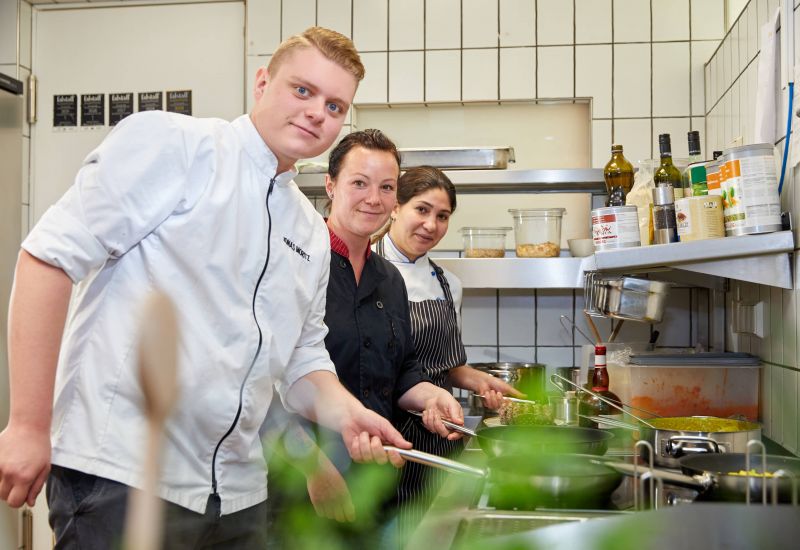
xmin=397 ymin=147 xmax=514 ymax=170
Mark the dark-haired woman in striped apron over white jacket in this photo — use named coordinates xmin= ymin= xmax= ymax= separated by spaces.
xmin=375 ymin=166 xmax=521 ymax=535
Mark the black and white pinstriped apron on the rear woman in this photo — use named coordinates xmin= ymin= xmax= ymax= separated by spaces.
xmin=397 ymin=260 xmax=467 ymax=538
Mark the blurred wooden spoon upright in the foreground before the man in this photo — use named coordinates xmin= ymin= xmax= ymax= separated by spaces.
xmin=125 ymin=293 xmax=178 ymax=550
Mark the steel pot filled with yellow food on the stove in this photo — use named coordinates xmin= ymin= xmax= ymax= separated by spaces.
xmin=639 ymin=416 xmax=761 ymax=468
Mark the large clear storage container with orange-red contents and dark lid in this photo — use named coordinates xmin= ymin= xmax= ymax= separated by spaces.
xmin=608 ymin=352 xmax=761 ymax=421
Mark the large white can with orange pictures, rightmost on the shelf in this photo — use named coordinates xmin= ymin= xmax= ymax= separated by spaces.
xmin=720 ymin=143 xmax=781 ymax=236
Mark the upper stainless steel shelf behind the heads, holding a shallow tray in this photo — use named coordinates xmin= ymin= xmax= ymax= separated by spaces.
xmin=294 ymin=168 xmax=606 ymax=194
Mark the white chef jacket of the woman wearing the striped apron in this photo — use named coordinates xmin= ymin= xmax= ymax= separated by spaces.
xmin=383 ymin=233 xmax=463 ymax=327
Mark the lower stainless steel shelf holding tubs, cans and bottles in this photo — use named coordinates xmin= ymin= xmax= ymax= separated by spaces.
xmin=436 ymin=231 xmax=794 ymax=288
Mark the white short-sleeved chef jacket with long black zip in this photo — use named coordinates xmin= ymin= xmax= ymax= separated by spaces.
xmin=22 ymin=111 xmax=335 ymax=514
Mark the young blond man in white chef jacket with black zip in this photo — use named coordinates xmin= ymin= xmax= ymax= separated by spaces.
xmin=0 ymin=28 xmax=432 ymax=548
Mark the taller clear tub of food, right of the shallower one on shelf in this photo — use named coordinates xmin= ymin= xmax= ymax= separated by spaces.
xmin=509 ymin=208 xmax=566 ymax=258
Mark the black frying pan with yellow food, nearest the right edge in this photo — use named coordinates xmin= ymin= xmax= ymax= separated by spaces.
xmin=593 ymin=453 xmax=800 ymax=502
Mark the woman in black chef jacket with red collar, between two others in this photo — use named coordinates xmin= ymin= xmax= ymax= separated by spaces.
xmin=268 ymin=130 xmax=463 ymax=547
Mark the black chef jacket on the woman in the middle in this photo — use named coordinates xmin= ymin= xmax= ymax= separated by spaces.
xmin=325 ymin=247 xmax=429 ymax=421
